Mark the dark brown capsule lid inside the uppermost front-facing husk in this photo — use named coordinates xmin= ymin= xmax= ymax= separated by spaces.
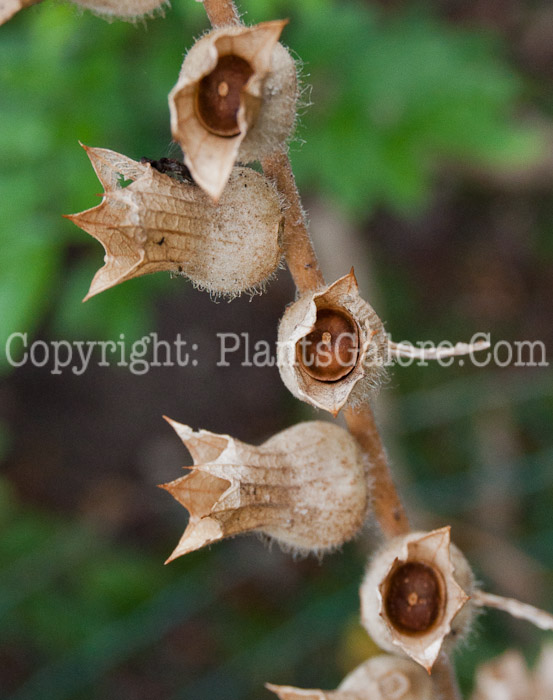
xmin=196 ymin=54 xmax=253 ymax=137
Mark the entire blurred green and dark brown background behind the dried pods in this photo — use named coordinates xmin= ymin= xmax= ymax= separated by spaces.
xmin=0 ymin=0 xmax=553 ymax=700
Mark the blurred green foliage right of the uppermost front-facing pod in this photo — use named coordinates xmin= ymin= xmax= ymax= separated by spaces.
xmin=282 ymin=3 xmax=542 ymax=217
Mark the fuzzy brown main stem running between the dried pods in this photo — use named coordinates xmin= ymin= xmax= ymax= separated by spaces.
xmin=199 ymin=5 xmax=462 ymax=700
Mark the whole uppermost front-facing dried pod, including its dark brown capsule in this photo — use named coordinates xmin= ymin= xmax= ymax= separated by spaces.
xmin=169 ymin=20 xmax=297 ymax=200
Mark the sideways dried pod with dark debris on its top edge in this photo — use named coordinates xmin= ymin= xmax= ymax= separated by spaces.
xmin=67 ymin=146 xmax=282 ymax=299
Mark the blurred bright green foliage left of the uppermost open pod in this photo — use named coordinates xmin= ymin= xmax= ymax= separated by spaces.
xmin=0 ymin=2 xmax=205 ymax=372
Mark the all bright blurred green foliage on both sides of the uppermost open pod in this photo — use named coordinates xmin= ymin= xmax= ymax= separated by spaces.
xmin=0 ymin=0 xmax=540 ymax=370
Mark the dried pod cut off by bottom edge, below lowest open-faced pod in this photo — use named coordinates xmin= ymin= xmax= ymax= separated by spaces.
xmin=267 ymin=655 xmax=433 ymax=700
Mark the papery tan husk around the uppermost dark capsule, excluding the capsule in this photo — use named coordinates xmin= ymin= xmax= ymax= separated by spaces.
xmin=169 ymin=20 xmax=297 ymax=200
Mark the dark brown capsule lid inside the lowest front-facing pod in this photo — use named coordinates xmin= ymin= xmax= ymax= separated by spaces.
xmin=384 ymin=562 xmax=443 ymax=634
